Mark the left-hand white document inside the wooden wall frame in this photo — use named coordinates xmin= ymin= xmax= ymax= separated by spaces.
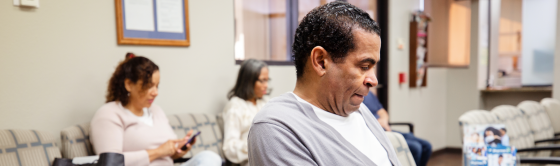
xmin=124 ymin=0 xmax=155 ymax=31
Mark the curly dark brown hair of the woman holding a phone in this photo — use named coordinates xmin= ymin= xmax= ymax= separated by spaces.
xmin=106 ymin=53 xmax=159 ymax=106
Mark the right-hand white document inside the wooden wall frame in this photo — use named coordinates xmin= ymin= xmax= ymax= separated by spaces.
xmin=156 ymin=0 xmax=185 ymax=33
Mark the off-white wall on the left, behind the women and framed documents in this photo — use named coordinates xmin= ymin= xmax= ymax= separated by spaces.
xmin=0 ymin=0 xmax=296 ymax=134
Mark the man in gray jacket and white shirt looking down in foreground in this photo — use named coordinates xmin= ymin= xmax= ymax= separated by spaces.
xmin=248 ymin=1 xmax=400 ymax=166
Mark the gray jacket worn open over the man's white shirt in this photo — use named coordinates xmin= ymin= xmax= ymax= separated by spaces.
xmin=248 ymin=93 xmax=400 ymax=166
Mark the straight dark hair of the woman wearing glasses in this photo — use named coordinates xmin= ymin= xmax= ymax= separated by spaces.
xmin=228 ymin=59 xmax=267 ymax=100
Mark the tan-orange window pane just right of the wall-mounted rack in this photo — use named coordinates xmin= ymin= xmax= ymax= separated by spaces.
xmin=424 ymin=0 xmax=471 ymax=67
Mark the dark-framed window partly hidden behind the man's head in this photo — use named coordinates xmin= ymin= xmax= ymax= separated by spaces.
xmin=234 ymin=0 xmax=377 ymax=65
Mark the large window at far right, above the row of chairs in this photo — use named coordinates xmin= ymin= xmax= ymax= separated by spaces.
xmin=480 ymin=0 xmax=558 ymax=89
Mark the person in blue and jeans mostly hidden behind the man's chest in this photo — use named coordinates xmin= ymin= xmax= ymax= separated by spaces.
xmin=364 ymin=91 xmax=432 ymax=166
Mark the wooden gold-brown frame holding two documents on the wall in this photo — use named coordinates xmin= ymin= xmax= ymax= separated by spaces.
xmin=115 ymin=0 xmax=190 ymax=46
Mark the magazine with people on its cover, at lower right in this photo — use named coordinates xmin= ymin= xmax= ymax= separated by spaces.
xmin=463 ymin=124 xmax=517 ymax=166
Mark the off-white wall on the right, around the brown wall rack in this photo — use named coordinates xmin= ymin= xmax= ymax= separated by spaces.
xmin=389 ymin=0 xmax=485 ymax=150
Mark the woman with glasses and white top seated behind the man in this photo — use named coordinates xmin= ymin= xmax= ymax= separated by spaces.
xmin=223 ymin=59 xmax=270 ymax=165
